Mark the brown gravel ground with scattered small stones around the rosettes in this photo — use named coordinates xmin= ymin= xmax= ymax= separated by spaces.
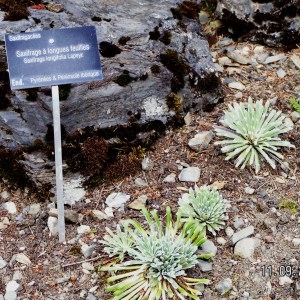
xmin=0 ymin=39 xmax=300 ymax=300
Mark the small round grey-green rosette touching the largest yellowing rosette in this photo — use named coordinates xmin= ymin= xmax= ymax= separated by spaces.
xmin=179 ymin=185 xmax=228 ymax=235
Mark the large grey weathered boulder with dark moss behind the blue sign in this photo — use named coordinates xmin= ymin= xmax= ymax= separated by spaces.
xmin=0 ymin=0 xmax=222 ymax=192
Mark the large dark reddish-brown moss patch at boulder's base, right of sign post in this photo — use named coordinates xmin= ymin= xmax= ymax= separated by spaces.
xmin=62 ymin=120 xmax=166 ymax=187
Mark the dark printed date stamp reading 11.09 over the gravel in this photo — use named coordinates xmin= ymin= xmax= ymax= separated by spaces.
xmin=260 ymin=265 xmax=300 ymax=279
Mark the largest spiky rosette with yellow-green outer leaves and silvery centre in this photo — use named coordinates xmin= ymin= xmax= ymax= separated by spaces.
xmin=99 ymin=208 xmax=213 ymax=300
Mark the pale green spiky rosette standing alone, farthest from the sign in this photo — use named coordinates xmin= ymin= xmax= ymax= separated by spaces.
xmin=215 ymin=97 xmax=295 ymax=173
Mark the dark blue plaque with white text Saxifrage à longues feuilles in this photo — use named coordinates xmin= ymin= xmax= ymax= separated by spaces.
xmin=5 ymin=26 xmax=103 ymax=90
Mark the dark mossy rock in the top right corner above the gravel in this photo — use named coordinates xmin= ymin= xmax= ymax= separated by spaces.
xmin=216 ymin=0 xmax=300 ymax=49
